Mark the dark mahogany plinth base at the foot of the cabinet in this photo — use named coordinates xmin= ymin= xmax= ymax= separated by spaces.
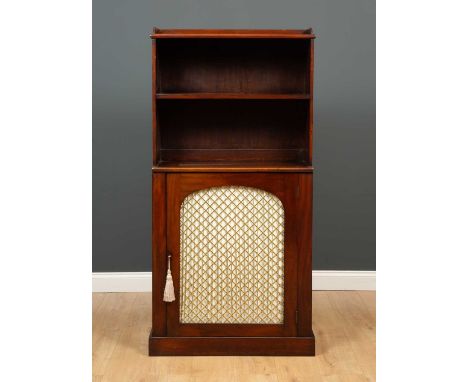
xmin=149 ymin=333 xmax=315 ymax=356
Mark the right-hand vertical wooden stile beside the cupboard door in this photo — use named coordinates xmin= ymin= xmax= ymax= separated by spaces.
xmin=297 ymin=174 xmax=313 ymax=337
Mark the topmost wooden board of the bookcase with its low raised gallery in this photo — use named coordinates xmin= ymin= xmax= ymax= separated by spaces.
xmin=151 ymin=28 xmax=315 ymax=39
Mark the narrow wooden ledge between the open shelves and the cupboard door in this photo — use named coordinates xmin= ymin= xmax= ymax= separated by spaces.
xmin=153 ymin=161 xmax=314 ymax=172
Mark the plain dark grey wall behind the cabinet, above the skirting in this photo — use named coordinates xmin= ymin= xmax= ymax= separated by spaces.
xmin=93 ymin=0 xmax=375 ymax=271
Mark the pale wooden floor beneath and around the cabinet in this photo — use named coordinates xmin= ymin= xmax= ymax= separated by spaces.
xmin=93 ymin=291 xmax=375 ymax=382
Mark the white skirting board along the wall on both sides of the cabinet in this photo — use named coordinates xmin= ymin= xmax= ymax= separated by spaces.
xmin=93 ymin=271 xmax=375 ymax=292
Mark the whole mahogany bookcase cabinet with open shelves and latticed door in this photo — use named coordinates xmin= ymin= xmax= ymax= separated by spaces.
xmin=149 ymin=28 xmax=315 ymax=355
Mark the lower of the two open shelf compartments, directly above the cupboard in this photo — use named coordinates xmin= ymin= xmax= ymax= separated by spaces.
xmin=158 ymin=99 xmax=308 ymax=163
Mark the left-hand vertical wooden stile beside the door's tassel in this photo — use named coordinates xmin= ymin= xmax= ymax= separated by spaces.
xmin=152 ymin=173 xmax=167 ymax=336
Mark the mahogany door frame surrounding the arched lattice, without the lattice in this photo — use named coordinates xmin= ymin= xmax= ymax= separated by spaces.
xmin=167 ymin=173 xmax=311 ymax=337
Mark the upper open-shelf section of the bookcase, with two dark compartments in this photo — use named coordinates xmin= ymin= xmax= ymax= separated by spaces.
xmin=153 ymin=28 xmax=313 ymax=167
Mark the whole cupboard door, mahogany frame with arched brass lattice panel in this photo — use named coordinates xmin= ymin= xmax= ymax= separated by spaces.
xmin=167 ymin=173 xmax=311 ymax=336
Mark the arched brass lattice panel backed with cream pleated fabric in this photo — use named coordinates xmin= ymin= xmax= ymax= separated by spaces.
xmin=179 ymin=186 xmax=284 ymax=324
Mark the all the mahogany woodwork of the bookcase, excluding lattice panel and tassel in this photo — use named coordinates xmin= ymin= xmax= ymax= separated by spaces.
xmin=149 ymin=28 xmax=315 ymax=355
